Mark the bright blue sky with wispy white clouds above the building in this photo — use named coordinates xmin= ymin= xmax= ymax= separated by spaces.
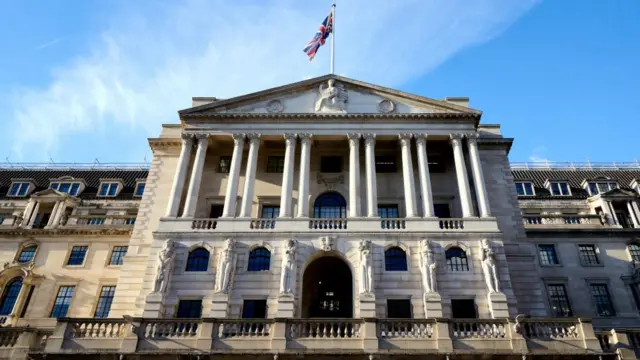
xmin=0 ymin=0 xmax=640 ymax=162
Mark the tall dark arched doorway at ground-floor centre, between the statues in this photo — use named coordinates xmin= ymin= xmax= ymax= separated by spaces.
xmin=302 ymin=256 xmax=353 ymax=318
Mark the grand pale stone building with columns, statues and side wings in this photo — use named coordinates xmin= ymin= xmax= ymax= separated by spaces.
xmin=0 ymin=75 xmax=640 ymax=360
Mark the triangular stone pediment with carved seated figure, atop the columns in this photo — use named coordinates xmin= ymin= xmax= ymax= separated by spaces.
xmin=179 ymin=75 xmax=482 ymax=118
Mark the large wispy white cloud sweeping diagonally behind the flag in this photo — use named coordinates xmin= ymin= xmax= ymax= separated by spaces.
xmin=4 ymin=0 xmax=537 ymax=160
